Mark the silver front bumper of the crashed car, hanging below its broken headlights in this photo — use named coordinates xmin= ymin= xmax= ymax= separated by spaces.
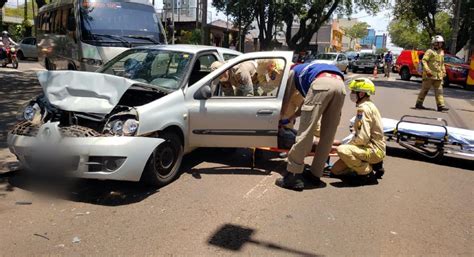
xmin=8 ymin=123 xmax=164 ymax=181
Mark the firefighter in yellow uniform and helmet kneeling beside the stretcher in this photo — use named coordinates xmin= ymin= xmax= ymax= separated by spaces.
xmin=331 ymin=78 xmax=386 ymax=182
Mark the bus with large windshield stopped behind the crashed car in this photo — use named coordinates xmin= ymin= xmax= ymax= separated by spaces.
xmin=35 ymin=0 xmax=166 ymax=71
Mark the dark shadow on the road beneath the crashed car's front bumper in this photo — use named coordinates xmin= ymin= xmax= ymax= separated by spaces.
xmin=0 ymin=171 xmax=158 ymax=206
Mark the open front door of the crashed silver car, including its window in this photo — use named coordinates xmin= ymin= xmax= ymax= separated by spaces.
xmin=186 ymin=52 xmax=292 ymax=147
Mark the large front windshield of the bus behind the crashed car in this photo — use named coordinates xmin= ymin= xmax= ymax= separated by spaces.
xmin=80 ymin=0 xmax=164 ymax=46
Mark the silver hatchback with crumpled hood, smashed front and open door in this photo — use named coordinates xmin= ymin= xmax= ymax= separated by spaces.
xmin=8 ymin=47 xmax=292 ymax=186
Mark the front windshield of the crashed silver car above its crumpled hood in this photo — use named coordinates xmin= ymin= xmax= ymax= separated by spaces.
xmin=98 ymin=49 xmax=193 ymax=90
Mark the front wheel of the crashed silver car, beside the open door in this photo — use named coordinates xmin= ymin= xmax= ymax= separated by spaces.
xmin=141 ymin=132 xmax=184 ymax=187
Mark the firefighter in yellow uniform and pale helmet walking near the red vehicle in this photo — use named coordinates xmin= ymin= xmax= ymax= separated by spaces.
xmin=415 ymin=35 xmax=449 ymax=112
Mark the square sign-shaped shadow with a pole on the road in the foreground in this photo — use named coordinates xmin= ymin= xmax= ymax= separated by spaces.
xmin=208 ymin=224 xmax=324 ymax=256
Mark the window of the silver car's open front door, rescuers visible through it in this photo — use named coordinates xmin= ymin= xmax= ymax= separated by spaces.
xmin=211 ymin=58 xmax=285 ymax=98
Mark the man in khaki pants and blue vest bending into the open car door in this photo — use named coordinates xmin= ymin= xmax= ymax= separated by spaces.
xmin=275 ymin=63 xmax=346 ymax=190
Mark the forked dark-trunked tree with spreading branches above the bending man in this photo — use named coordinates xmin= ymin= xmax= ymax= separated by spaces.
xmin=280 ymin=0 xmax=389 ymax=51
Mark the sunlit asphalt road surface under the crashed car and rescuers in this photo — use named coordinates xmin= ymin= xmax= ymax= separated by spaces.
xmin=0 ymin=61 xmax=474 ymax=256
